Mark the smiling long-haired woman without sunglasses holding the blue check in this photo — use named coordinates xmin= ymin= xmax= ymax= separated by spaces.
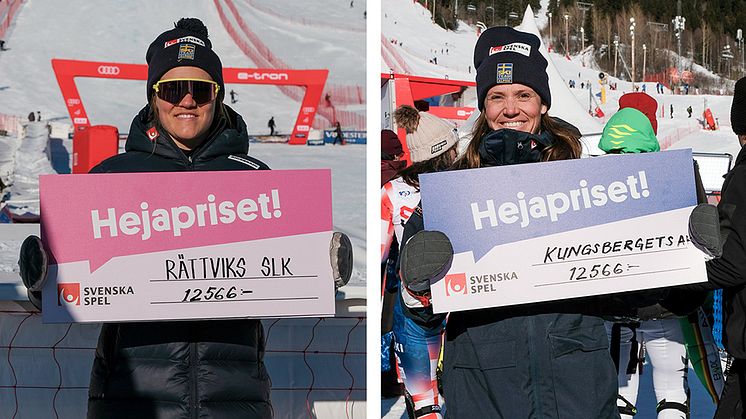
xmin=400 ymin=27 xmax=619 ymax=419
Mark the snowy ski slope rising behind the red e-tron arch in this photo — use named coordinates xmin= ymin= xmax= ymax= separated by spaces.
xmin=0 ymin=0 xmax=366 ymax=134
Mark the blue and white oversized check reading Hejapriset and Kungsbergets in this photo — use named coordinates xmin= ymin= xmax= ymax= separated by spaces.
xmin=421 ymin=150 xmax=707 ymax=313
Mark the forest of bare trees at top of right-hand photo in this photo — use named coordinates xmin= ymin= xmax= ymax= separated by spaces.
xmin=418 ymin=0 xmax=746 ymax=87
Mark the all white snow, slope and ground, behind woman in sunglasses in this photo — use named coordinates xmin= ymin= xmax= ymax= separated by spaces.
xmin=0 ymin=0 xmax=366 ymax=285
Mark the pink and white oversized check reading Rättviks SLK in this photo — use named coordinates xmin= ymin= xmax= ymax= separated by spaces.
xmin=39 ymin=169 xmax=334 ymax=323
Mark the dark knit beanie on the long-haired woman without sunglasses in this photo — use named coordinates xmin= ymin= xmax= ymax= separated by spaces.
xmin=474 ymin=26 xmax=552 ymax=111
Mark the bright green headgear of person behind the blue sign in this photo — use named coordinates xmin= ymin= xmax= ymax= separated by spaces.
xmin=598 ymin=108 xmax=661 ymax=153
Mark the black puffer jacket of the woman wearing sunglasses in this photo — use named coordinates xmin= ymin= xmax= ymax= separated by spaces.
xmin=88 ymin=106 xmax=272 ymax=419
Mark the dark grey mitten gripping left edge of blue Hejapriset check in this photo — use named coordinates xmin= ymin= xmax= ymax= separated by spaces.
xmin=399 ymin=231 xmax=453 ymax=293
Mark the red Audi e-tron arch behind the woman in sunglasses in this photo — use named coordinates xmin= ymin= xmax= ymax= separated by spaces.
xmin=52 ymin=58 xmax=329 ymax=144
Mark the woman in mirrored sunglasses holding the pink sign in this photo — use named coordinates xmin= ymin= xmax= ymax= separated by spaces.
xmin=19 ymin=18 xmax=351 ymax=419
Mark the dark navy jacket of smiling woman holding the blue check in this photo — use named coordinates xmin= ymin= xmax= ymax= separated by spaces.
xmin=402 ymin=130 xmax=627 ymax=419
